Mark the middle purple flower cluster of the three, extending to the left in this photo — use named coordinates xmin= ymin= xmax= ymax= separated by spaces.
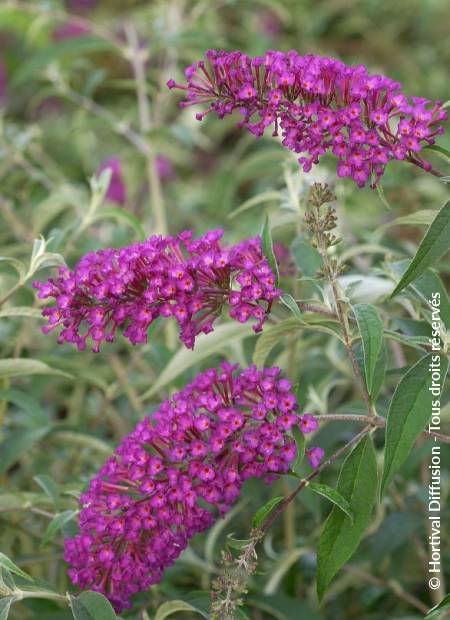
xmin=34 ymin=230 xmax=281 ymax=351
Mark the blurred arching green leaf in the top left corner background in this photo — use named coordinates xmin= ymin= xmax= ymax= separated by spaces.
xmin=12 ymin=36 xmax=111 ymax=86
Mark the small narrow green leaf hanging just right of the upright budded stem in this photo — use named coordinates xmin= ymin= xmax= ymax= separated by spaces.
xmin=352 ymin=304 xmax=384 ymax=396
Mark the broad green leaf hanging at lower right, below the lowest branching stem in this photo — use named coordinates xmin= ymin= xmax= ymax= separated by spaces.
xmin=317 ymin=435 xmax=377 ymax=600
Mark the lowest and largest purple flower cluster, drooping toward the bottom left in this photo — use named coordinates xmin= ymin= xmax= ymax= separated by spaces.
xmin=65 ymin=363 xmax=317 ymax=611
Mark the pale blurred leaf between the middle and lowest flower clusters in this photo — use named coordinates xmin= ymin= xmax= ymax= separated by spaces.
xmin=141 ymin=323 xmax=254 ymax=401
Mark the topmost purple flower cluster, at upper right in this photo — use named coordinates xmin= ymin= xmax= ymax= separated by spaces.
xmin=168 ymin=50 xmax=447 ymax=187
